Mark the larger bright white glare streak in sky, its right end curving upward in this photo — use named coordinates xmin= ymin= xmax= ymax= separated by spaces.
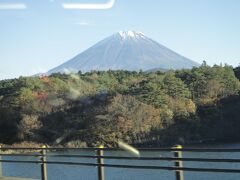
xmin=62 ymin=0 xmax=115 ymax=9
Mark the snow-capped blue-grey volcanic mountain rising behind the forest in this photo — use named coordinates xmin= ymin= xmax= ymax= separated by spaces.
xmin=47 ymin=31 xmax=199 ymax=74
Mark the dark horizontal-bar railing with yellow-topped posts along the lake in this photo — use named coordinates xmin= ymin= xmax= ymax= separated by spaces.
xmin=0 ymin=146 xmax=240 ymax=180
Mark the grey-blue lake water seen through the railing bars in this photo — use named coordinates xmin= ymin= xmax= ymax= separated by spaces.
xmin=2 ymin=143 xmax=240 ymax=180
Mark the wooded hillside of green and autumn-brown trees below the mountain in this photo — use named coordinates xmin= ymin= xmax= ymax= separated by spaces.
xmin=0 ymin=62 xmax=240 ymax=147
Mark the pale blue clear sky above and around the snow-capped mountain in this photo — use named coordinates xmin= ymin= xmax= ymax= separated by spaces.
xmin=0 ymin=0 xmax=240 ymax=79
